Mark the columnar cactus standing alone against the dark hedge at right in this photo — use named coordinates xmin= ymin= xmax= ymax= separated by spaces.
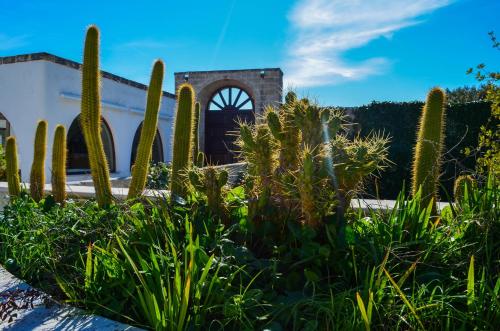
xmin=412 ymin=88 xmax=446 ymax=211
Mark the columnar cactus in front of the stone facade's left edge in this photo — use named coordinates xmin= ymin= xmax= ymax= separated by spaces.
xmin=170 ymin=84 xmax=195 ymax=197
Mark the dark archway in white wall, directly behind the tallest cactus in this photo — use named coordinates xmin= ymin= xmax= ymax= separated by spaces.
xmin=66 ymin=115 xmax=115 ymax=174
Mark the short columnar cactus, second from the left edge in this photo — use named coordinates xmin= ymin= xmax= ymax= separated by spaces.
xmin=30 ymin=120 xmax=47 ymax=202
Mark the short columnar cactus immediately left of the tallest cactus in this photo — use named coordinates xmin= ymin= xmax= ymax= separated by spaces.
xmin=51 ymin=124 xmax=66 ymax=205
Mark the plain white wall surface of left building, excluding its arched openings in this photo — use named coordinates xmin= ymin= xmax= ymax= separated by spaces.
xmin=0 ymin=61 xmax=175 ymax=182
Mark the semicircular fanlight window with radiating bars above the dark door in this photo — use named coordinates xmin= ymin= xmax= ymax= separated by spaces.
xmin=208 ymin=86 xmax=253 ymax=111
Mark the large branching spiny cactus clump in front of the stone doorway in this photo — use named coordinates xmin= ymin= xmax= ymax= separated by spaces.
xmin=238 ymin=93 xmax=388 ymax=227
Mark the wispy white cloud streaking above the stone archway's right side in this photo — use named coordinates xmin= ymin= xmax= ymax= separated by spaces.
xmin=285 ymin=0 xmax=454 ymax=87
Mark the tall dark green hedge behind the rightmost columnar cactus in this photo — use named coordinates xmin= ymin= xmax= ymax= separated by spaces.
xmin=350 ymin=102 xmax=490 ymax=200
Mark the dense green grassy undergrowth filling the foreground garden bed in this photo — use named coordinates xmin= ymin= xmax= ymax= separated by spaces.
xmin=0 ymin=176 xmax=500 ymax=330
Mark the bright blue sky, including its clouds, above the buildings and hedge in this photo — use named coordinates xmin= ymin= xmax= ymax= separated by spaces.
xmin=0 ymin=0 xmax=500 ymax=106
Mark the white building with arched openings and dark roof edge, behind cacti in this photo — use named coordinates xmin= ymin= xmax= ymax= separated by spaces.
xmin=0 ymin=53 xmax=175 ymax=182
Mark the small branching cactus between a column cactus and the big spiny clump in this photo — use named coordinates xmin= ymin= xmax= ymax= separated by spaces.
xmin=188 ymin=166 xmax=228 ymax=219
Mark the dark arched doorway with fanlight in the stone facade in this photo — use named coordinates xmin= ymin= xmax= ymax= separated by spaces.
xmin=205 ymin=86 xmax=255 ymax=164
